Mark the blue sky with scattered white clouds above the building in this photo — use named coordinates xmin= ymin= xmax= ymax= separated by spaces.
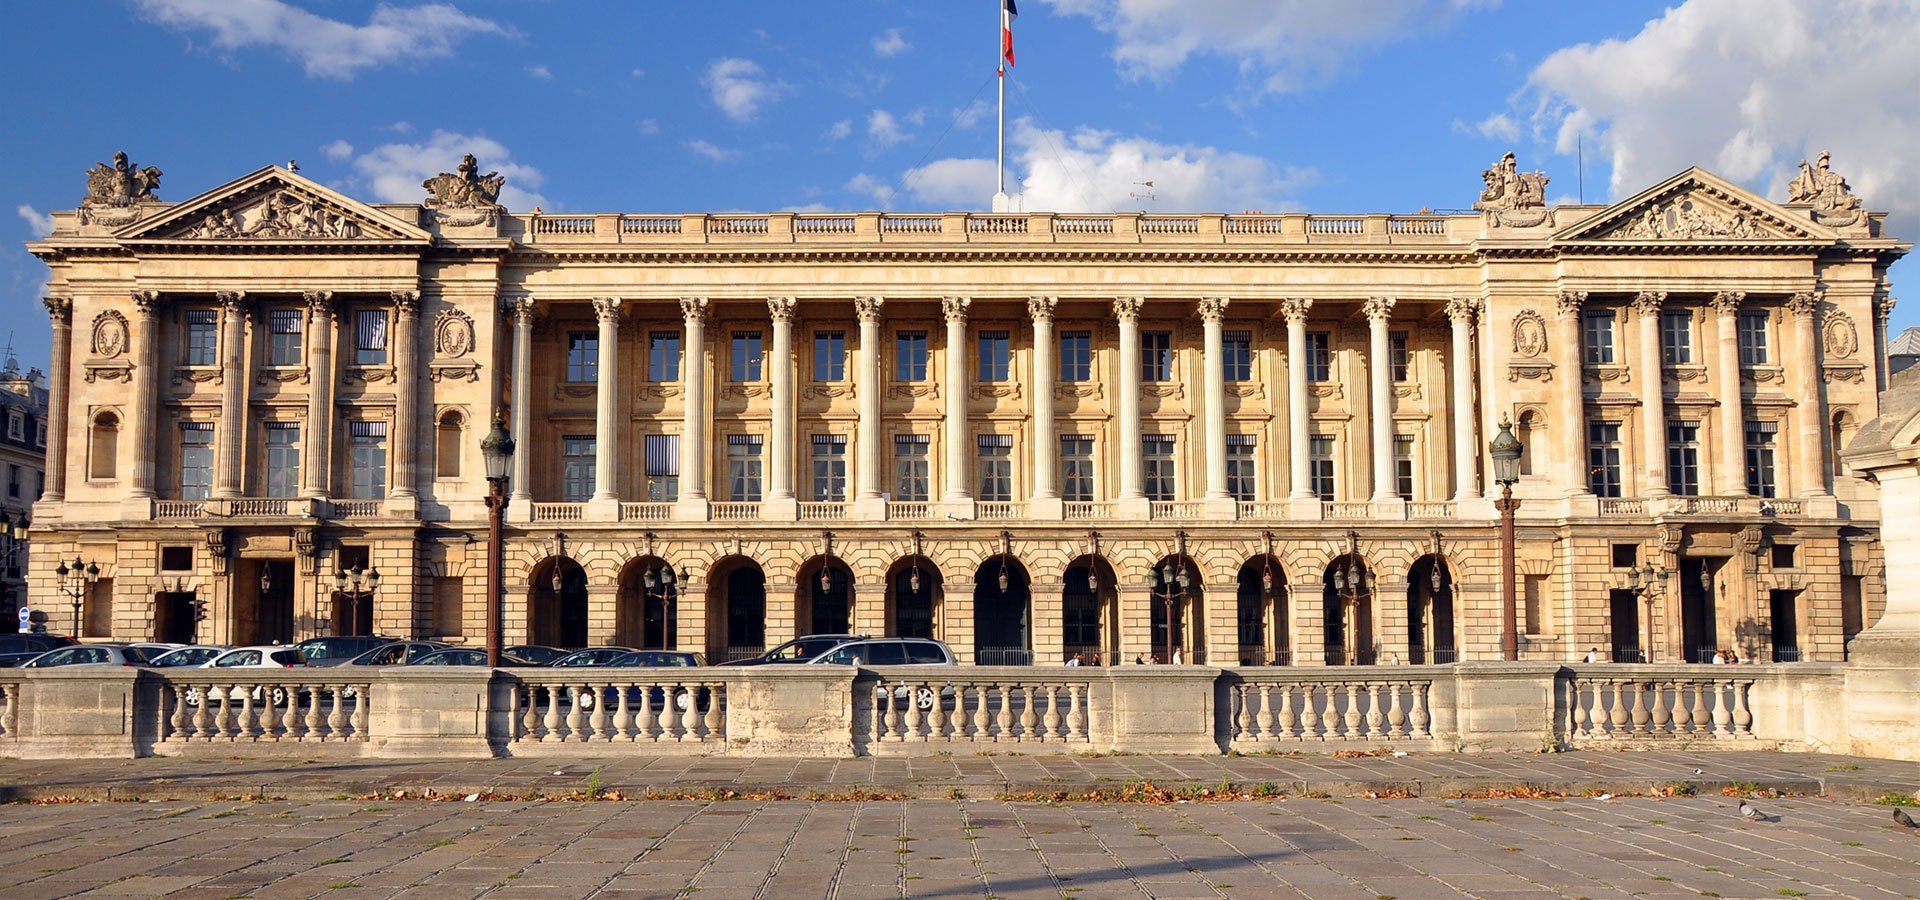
xmin=0 ymin=0 xmax=1920 ymax=367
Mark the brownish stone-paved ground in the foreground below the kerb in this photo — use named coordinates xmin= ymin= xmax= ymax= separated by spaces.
xmin=0 ymin=796 xmax=1920 ymax=900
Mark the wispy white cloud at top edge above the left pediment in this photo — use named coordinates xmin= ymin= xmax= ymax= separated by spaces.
xmin=134 ymin=0 xmax=511 ymax=81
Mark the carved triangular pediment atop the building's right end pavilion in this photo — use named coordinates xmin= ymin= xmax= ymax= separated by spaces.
xmin=1553 ymin=167 xmax=1837 ymax=244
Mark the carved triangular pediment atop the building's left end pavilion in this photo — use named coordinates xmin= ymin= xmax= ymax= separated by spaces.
xmin=115 ymin=165 xmax=434 ymax=244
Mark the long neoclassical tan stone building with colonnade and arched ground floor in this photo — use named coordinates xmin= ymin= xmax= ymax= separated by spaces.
xmin=29 ymin=154 xmax=1908 ymax=666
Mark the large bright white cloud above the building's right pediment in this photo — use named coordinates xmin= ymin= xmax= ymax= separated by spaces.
xmin=1528 ymin=0 xmax=1920 ymax=234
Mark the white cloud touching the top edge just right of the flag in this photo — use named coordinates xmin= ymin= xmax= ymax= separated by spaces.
xmin=1044 ymin=0 xmax=1500 ymax=90
